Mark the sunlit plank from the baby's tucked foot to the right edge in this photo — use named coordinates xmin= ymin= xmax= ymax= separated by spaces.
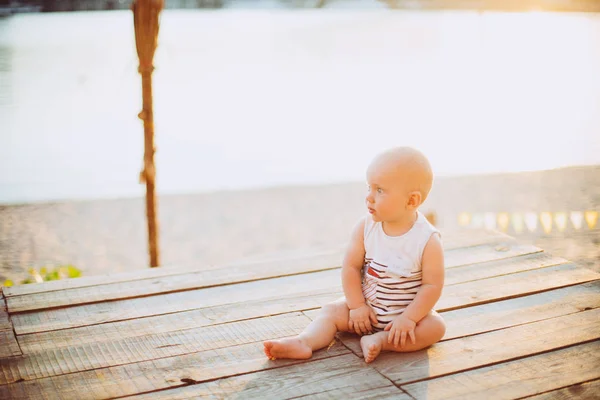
xmin=372 ymin=308 xmax=600 ymax=385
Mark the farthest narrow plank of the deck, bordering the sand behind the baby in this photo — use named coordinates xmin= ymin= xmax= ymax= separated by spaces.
xmin=4 ymin=229 xmax=514 ymax=297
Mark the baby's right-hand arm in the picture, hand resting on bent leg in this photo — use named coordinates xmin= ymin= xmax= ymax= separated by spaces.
xmin=385 ymin=234 xmax=444 ymax=347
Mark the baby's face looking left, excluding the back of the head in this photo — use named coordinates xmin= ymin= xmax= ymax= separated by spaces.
xmin=366 ymin=161 xmax=413 ymax=222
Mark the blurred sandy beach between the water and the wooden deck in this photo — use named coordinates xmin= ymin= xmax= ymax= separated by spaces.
xmin=0 ymin=166 xmax=600 ymax=281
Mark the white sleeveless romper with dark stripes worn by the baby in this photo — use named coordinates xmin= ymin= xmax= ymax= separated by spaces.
xmin=362 ymin=212 xmax=440 ymax=331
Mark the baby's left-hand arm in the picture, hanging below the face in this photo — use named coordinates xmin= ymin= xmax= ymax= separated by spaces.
xmin=342 ymin=218 xmax=377 ymax=335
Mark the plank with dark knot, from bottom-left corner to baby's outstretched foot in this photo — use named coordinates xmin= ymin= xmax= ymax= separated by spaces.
xmin=0 ymin=342 xmax=352 ymax=399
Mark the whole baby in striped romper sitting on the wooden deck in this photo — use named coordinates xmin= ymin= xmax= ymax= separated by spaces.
xmin=264 ymin=147 xmax=446 ymax=363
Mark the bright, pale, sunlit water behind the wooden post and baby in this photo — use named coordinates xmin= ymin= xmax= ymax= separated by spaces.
xmin=0 ymin=10 xmax=600 ymax=203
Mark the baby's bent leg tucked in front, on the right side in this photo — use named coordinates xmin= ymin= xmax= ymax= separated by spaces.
xmin=360 ymin=311 xmax=446 ymax=362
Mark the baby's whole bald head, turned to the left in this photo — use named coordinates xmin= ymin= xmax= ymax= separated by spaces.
xmin=366 ymin=147 xmax=433 ymax=222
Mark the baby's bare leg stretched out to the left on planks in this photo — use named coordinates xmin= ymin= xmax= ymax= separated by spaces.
xmin=264 ymin=298 xmax=349 ymax=359
